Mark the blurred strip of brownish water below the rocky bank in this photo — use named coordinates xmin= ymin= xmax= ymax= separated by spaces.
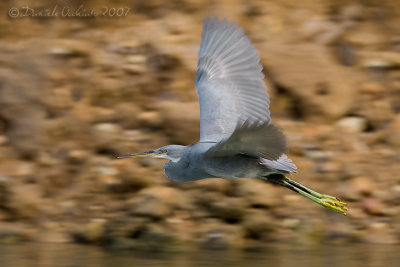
xmin=0 ymin=243 xmax=400 ymax=267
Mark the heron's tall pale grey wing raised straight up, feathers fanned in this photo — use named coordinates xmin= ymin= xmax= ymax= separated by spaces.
xmin=195 ymin=17 xmax=270 ymax=142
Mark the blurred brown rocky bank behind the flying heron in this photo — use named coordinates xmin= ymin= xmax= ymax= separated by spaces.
xmin=0 ymin=0 xmax=400 ymax=250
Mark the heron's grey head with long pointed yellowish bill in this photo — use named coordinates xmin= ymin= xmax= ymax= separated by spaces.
xmin=118 ymin=145 xmax=186 ymax=162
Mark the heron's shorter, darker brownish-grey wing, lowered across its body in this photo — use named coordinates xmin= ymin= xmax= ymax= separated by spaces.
xmin=206 ymin=121 xmax=287 ymax=161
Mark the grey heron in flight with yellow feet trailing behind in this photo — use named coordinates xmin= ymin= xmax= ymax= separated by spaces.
xmin=119 ymin=17 xmax=347 ymax=215
